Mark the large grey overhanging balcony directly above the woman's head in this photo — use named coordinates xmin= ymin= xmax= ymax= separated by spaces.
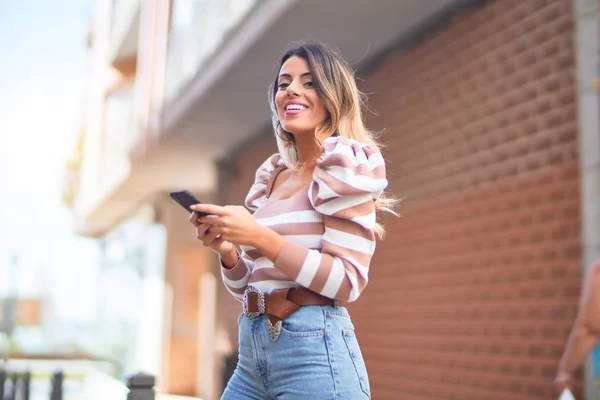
xmin=160 ymin=0 xmax=454 ymax=158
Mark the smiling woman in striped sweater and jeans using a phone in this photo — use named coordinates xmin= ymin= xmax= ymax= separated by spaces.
xmin=190 ymin=42 xmax=394 ymax=400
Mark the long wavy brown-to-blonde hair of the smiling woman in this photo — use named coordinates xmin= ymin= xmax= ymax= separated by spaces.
xmin=269 ymin=41 xmax=398 ymax=238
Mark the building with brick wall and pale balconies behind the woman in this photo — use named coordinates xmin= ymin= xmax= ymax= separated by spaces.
xmin=68 ymin=0 xmax=600 ymax=399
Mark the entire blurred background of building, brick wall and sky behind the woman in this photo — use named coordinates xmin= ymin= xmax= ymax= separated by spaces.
xmin=0 ymin=0 xmax=600 ymax=400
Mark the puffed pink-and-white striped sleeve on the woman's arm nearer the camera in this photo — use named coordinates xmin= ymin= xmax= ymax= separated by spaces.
xmin=275 ymin=137 xmax=388 ymax=302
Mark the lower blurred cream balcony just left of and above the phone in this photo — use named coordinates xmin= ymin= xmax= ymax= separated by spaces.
xmin=74 ymin=82 xmax=216 ymax=237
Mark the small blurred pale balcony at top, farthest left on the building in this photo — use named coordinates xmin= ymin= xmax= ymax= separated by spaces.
xmin=109 ymin=0 xmax=141 ymax=70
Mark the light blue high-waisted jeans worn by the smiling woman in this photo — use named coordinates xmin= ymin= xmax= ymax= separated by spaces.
xmin=221 ymin=306 xmax=371 ymax=400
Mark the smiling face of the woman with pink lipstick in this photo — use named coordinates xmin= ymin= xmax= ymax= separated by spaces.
xmin=275 ymin=56 xmax=327 ymax=135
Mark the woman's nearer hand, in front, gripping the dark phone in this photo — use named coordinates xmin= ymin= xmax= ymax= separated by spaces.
xmin=192 ymin=204 xmax=265 ymax=246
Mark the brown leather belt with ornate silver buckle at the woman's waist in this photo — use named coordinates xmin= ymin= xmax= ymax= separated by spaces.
xmin=243 ymin=286 xmax=337 ymax=340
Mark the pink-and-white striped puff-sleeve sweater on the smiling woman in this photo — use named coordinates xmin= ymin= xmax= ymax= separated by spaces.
xmin=221 ymin=137 xmax=388 ymax=301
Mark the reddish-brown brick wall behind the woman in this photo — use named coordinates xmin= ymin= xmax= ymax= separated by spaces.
xmin=214 ymin=0 xmax=581 ymax=400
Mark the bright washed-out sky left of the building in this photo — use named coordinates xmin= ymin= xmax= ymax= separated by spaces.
xmin=0 ymin=0 xmax=99 ymax=322
